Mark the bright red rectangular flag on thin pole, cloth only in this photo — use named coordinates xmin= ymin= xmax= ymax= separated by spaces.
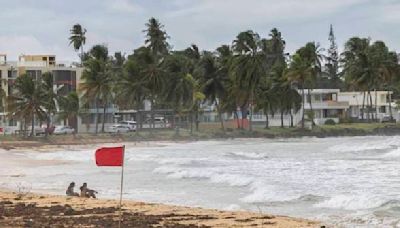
xmin=96 ymin=146 xmax=124 ymax=166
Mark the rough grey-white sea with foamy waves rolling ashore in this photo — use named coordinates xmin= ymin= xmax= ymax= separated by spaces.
xmin=0 ymin=136 xmax=400 ymax=227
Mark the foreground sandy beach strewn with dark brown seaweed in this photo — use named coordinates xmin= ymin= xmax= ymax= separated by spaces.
xmin=0 ymin=189 xmax=321 ymax=228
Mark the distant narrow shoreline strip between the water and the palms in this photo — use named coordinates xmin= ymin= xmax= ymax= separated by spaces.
xmin=0 ymin=124 xmax=400 ymax=150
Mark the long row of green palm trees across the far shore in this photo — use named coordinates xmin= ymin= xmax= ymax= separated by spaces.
xmin=3 ymin=18 xmax=400 ymax=136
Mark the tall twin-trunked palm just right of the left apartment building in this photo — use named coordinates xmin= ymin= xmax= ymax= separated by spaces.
xmin=80 ymin=45 xmax=114 ymax=134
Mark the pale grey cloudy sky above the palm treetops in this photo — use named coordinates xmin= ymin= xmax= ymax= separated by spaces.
xmin=0 ymin=0 xmax=400 ymax=61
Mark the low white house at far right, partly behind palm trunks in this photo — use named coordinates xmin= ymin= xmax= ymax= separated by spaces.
xmin=339 ymin=91 xmax=398 ymax=120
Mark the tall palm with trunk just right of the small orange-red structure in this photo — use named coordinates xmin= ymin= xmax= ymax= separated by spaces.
xmin=231 ymin=31 xmax=267 ymax=131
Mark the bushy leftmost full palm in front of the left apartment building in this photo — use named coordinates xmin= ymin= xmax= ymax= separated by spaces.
xmin=7 ymin=74 xmax=47 ymax=136
